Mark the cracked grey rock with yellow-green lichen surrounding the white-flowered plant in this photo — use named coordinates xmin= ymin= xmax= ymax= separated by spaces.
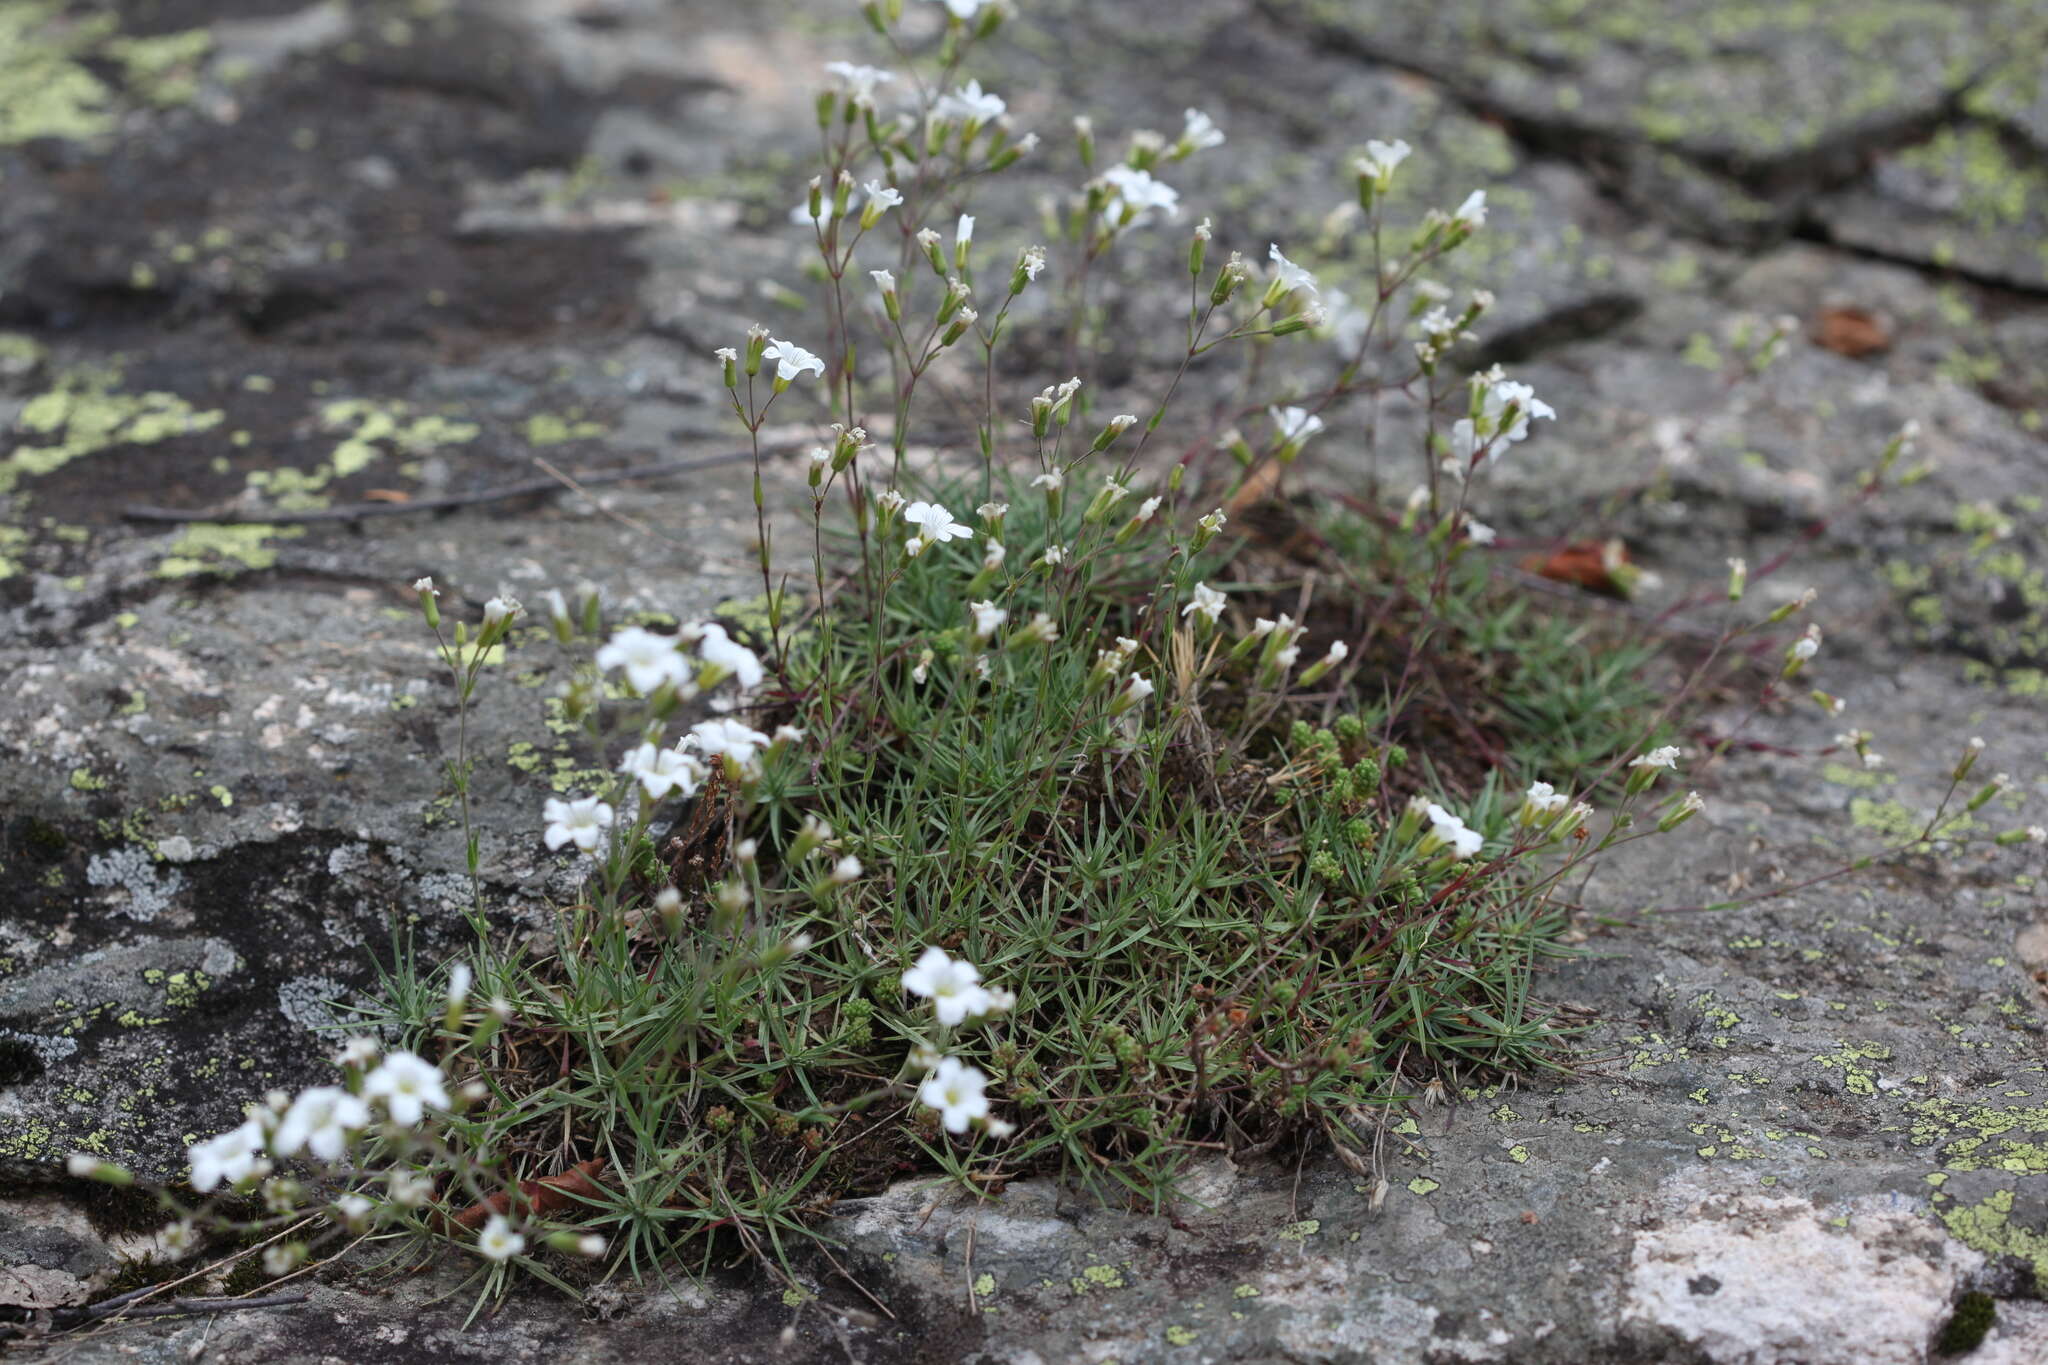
xmin=0 ymin=0 xmax=2048 ymax=1365
